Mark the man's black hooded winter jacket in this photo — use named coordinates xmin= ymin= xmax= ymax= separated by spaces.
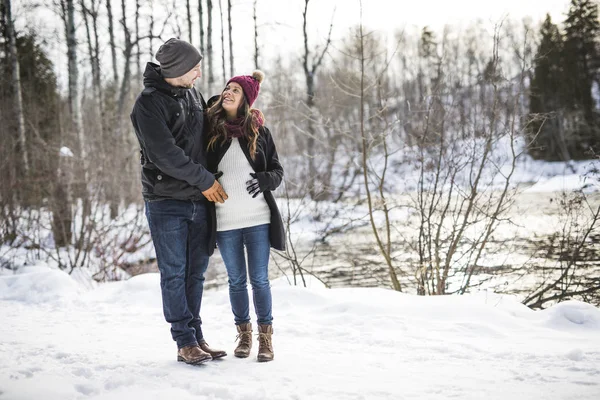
xmin=131 ymin=63 xmax=215 ymax=201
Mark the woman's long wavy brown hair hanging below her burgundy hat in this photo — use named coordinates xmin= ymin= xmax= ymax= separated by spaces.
xmin=206 ymin=95 xmax=265 ymax=160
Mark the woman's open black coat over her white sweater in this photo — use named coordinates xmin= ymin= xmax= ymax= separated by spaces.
xmin=207 ymin=127 xmax=285 ymax=251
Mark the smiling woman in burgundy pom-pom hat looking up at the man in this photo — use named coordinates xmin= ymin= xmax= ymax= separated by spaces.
xmin=207 ymin=71 xmax=285 ymax=361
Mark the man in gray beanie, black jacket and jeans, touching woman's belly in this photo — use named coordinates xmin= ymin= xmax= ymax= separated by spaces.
xmin=131 ymin=39 xmax=227 ymax=365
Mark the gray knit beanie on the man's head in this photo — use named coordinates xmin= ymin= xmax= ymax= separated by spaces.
xmin=156 ymin=38 xmax=202 ymax=78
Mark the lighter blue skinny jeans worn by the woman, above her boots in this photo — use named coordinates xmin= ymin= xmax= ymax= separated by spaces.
xmin=217 ymin=224 xmax=273 ymax=325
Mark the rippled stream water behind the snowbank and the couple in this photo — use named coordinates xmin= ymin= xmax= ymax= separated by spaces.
xmin=127 ymin=193 xmax=600 ymax=304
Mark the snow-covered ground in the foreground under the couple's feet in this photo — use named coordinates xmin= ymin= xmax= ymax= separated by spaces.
xmin=0 ymin=267 xmax=600 ymax=400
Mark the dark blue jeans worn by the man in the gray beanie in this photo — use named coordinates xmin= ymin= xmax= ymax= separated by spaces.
xmin=146 ymin=200 xmax=209 ymax=348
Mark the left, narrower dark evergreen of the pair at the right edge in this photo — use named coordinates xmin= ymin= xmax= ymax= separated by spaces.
xmin=526 ymin=15 xmax=570 ymax=160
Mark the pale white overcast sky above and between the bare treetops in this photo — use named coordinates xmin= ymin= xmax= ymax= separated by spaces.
xmin=13 ymin=0 xmax=570 ymax=90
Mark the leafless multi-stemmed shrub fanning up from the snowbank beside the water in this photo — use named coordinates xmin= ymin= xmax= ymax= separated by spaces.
xmin=407 ymin=24 xmax=527 ymax=295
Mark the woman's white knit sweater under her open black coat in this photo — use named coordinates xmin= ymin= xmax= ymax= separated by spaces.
xmin=215 ymin=138 xmax=271 ymax=231
